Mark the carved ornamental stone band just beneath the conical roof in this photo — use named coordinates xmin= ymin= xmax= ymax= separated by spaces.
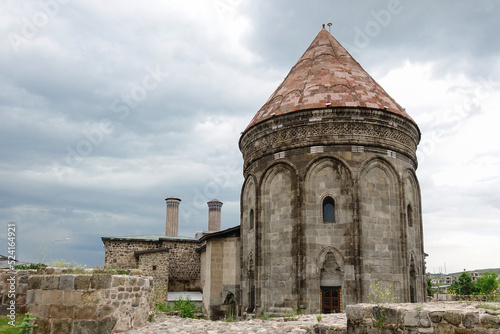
xmin=240 ymin=111 xmax=420 ymax=166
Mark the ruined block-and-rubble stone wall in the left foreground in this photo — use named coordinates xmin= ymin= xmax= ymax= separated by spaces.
xmin=27 ymin=274 xmax=152 ymax=334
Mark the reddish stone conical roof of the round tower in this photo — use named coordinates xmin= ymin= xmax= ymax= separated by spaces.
xmin=247 ymin=26 xmax=414 ymax=129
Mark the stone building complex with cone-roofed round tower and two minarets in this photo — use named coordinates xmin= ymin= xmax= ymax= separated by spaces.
xmin=102 ymin=25 xmax=426 ymax=319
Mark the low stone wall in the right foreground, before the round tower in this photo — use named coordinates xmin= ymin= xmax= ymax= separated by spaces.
xmin=346 ymin=302 xmax=500 ymax=334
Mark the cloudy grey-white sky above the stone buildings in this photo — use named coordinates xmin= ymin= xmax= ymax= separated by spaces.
xmin=0 ymin=0 xmax=500 ymax=272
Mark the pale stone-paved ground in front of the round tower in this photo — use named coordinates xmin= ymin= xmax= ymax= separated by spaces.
xmin=126 ymin=313 xmax=347 ymax=334
